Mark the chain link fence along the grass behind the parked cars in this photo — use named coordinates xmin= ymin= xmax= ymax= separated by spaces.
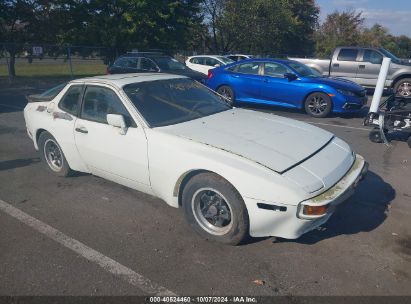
xmin=0 ymin=43 xmax=316 ymax=82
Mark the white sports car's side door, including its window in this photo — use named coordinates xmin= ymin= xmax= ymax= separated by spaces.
xmin=74 ymin=85 xmax=150 ymax=192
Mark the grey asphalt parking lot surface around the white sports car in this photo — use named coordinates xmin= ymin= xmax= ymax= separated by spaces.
xmin=0 ymin=82 xmax=411 ymax=295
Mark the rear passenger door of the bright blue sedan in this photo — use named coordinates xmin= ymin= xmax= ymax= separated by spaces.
xmin=227 ymin=61 xmax=263 ymax=102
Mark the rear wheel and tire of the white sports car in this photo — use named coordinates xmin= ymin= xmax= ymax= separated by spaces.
xmin=38 ymin=132 xmax=73 ymax=177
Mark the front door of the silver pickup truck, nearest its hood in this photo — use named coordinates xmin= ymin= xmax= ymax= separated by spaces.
xmin=357 ymin=49 xmax=384 ymax=86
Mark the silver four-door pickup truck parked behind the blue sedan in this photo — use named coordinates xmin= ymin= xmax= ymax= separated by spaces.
xmin=289 ymin=47 xmax=411 ymax=97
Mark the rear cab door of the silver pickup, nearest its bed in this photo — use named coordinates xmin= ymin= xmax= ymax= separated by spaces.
xmin=331 ymin=48 xmax=359 ymax=81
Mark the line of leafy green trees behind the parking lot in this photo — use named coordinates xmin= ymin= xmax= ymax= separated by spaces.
xmin=0 ymin=0 xmax=411 ymax=75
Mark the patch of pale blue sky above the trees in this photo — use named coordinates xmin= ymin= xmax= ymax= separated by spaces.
xmin=316 ymin=0 xmax=411 ymax=37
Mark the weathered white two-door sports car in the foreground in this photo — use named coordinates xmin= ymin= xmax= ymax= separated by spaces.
xmin=24 ymin=73 xmax=368 ymax=244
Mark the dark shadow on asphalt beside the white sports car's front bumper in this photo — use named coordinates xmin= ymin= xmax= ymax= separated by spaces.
xmin=277 ymin=171 xmax=396 ymax=245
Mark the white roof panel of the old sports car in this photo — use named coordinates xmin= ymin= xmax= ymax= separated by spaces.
xmin=70 ymin=73 xmax=188 ymax=88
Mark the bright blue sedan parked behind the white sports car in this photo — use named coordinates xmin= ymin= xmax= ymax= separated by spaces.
xmin=206 ymin=59 xmax=367 ymax=117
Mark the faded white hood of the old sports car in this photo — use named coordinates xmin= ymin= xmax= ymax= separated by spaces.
xmin=157 ymin=109 xmax=334 ymax=173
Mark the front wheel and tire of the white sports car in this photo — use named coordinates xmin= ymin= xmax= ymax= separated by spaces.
xmin=182 ymin=173 xmax=249 ymax=245
